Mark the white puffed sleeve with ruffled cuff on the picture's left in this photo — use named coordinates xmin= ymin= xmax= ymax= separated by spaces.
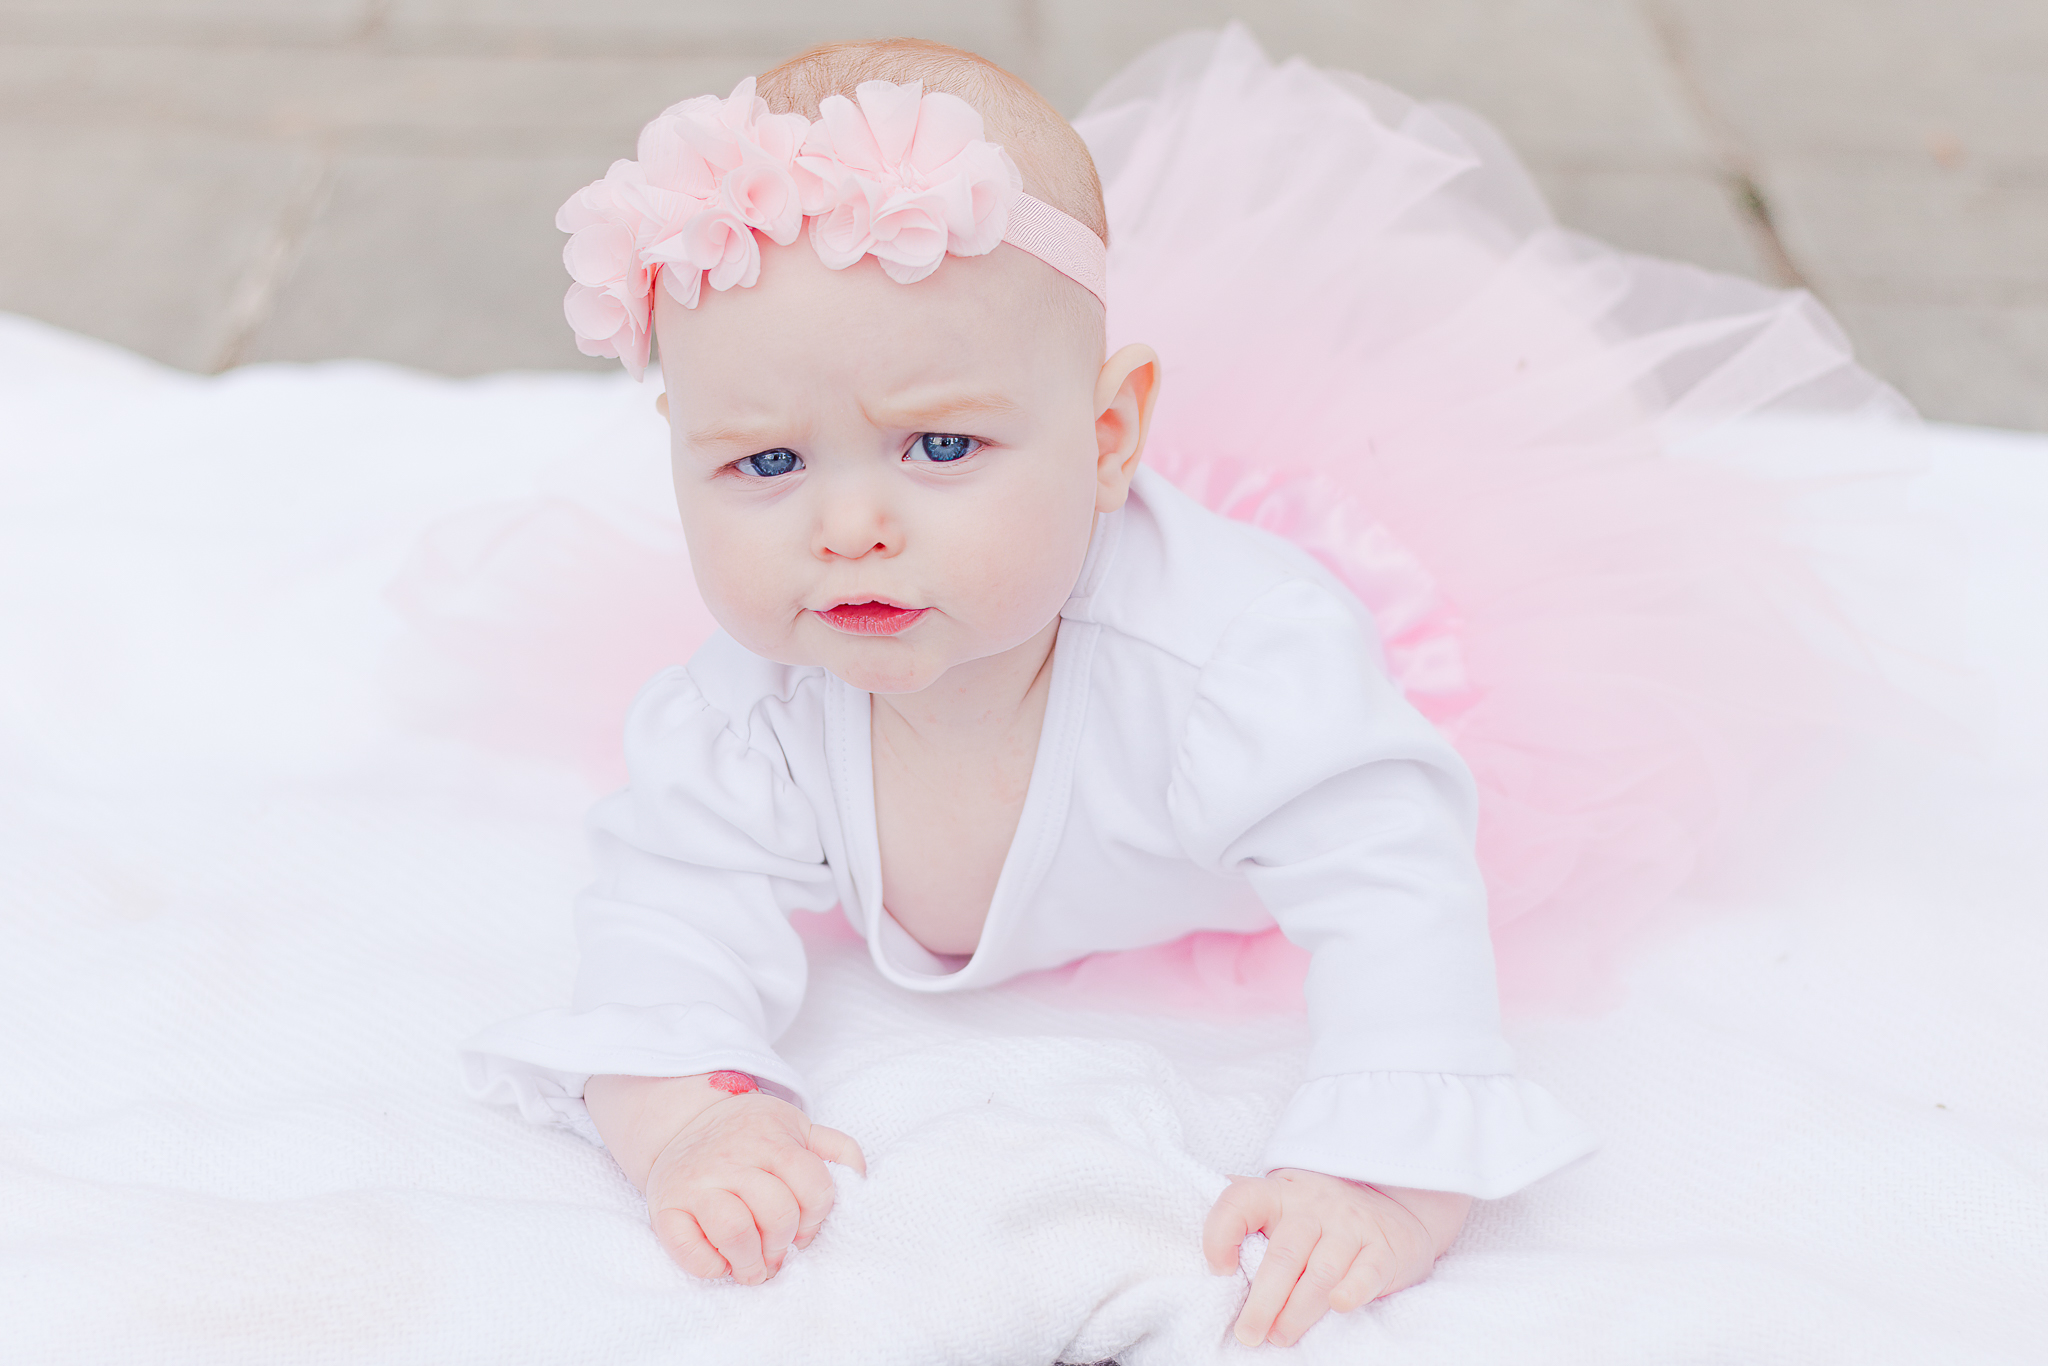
xmin=463 ymin=655 xmax=838 ymax=1141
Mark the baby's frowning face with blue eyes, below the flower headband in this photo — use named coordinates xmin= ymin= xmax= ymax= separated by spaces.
xmin=655 ymin=238 xmax=1135 ymax=692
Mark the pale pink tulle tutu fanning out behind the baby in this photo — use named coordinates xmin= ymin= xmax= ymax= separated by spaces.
xmin=395 ymin=29 xmax=1911 ymax=1012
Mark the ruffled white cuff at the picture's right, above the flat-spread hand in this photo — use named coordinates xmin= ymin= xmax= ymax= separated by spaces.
xmin=1260 ymin=1071 xmax=1599 ymax=1200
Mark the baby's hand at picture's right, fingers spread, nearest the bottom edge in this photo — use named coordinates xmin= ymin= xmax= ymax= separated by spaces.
xmin=1202 ymin=1167 xmax=1473 ymax=1348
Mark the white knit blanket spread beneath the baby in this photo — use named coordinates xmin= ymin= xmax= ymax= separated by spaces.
xmin=0 ymin=319 xmax=2048 ymax=1366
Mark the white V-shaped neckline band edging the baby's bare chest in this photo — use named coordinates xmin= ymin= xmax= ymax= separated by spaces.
xmin=825 ymin=497 xmax=1122 ymax=991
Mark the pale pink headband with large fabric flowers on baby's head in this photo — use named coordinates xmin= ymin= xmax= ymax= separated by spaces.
xmin=555 ymin=76 xmax=1108 ymax=377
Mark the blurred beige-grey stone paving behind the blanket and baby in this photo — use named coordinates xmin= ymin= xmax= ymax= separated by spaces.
xmin=0 ymin=0 xmax=2048 ymax=430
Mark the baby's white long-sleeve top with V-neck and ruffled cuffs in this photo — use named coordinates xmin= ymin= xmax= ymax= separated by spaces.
xmin=465 ymin=471 xmax=1593 ymax=1196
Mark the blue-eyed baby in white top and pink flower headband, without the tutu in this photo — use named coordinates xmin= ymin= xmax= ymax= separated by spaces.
xmin=471 ymin=41 xmax=1589 ymax=1343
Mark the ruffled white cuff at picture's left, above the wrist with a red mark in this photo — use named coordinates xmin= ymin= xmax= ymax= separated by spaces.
xmin=463 ymin=1006 xmax=805 ymax=1147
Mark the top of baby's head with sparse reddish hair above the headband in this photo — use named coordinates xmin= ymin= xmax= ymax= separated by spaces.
xmin=756 ymin=39 xmax=1110 ymax=242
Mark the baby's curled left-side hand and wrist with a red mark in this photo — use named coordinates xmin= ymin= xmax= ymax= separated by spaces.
xmin=584 ymin=1073 xmax=868 ymax=1286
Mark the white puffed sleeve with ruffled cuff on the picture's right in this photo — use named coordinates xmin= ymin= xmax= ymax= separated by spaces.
xmin=1167 ymin=580 xmax=1595 ymax=1196
